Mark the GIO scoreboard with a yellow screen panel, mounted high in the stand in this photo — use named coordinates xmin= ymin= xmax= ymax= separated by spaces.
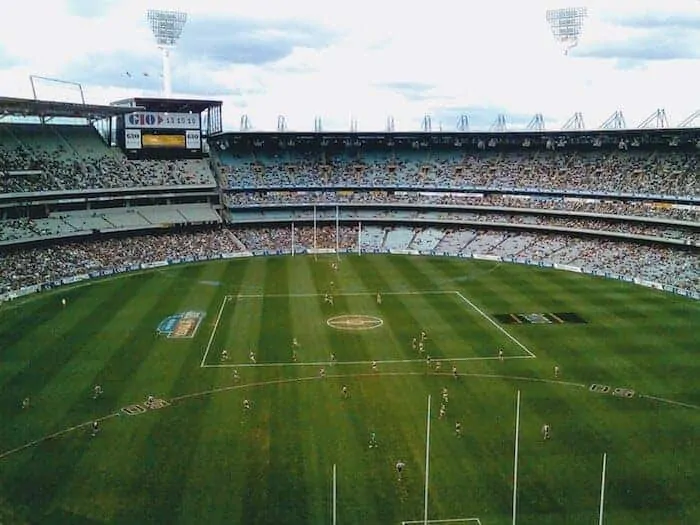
xmin=118 ymin=111 xmax=202 ymax=158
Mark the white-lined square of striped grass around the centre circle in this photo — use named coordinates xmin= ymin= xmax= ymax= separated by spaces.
xmin=202 ymin=291 xmax=534 ymax=367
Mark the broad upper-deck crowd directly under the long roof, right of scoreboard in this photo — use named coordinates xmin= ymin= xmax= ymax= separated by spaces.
xmin=217 ymin=151 xmax=700 ymax=196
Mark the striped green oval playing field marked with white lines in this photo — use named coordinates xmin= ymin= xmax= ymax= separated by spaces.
xmin=0 ymin=256 xmax=700 ymax=525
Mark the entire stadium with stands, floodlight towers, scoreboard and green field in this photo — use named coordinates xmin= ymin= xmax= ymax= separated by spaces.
xmin=0 ymin=4 xmax=700 ymax=525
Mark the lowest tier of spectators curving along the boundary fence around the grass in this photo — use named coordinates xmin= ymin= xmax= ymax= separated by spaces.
xmin=0 ymin=223 xmax=700 ymax=293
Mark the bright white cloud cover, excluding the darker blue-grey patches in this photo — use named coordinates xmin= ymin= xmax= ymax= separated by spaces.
xmin=0 ymin=0 xmax=700 ymax=129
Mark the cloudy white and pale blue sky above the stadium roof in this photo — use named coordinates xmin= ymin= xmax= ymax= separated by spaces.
xmin=0 ymin=0 xmax=700 ymax=131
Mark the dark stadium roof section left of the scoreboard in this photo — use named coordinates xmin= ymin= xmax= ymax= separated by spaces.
xmin=0 ymin=97 xmax=140 ymax=119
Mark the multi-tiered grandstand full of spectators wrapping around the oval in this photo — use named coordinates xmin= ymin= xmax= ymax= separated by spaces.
xmin=0 ymin=106 xmax=700 ymax=300
